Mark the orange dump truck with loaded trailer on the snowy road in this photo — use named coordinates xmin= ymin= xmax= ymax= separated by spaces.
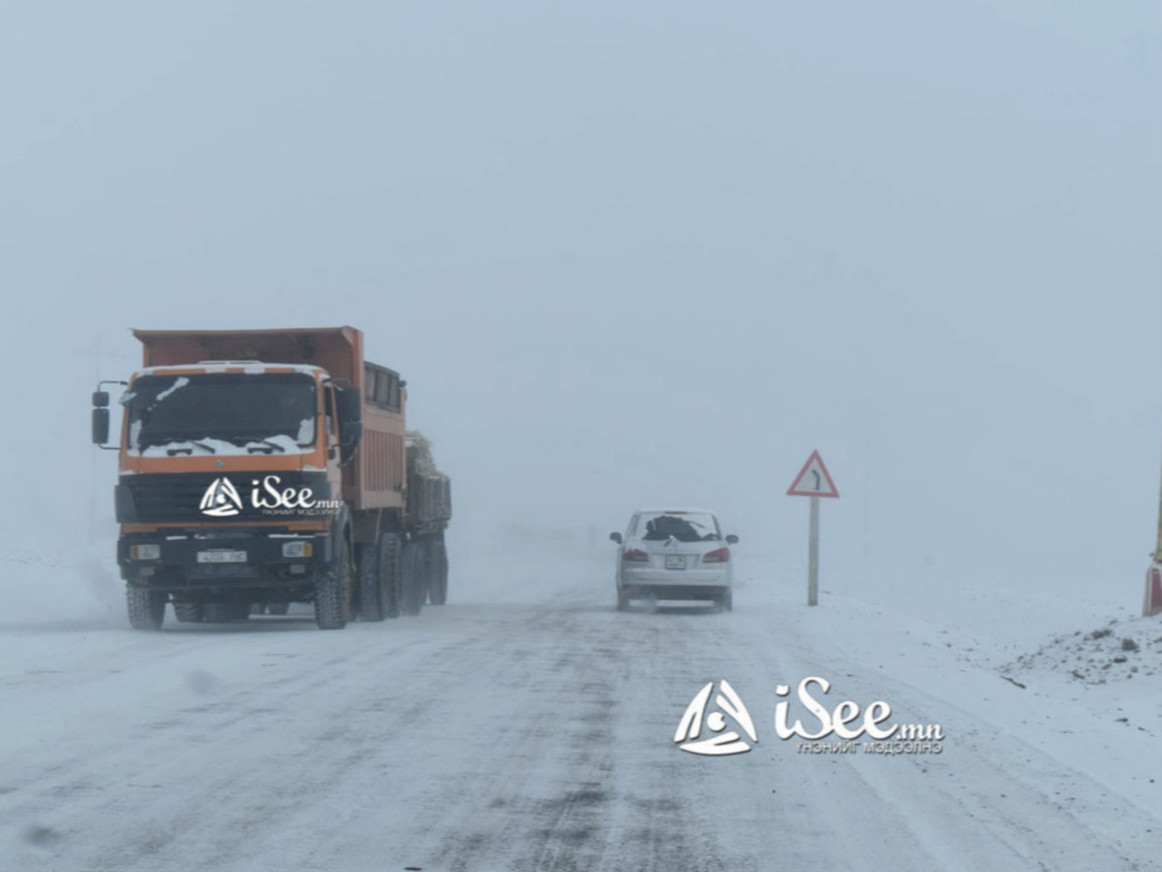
xmin=92 ymin=327 xmax=452 ymax=629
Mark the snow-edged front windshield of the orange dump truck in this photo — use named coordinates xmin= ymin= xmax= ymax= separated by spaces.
xmin=121 ymin=372 xmax=317 ymax=456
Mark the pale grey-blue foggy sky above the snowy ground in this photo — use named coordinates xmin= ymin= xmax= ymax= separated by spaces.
xmin=0 ymin=0 xmax=1162 ymax=605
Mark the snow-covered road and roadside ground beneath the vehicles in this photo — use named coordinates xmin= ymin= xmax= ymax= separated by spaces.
xmin=0 ymin=543 xmax=1162 ymax=872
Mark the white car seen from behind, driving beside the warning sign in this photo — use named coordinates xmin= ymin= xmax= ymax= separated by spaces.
xmin=609 ymin=508 xmax=738 ymax=612
